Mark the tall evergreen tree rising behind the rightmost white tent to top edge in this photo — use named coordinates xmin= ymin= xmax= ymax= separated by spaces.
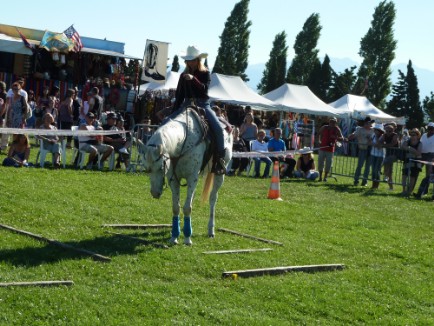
xmin=358 ymin=0 xmax=397 ymax=108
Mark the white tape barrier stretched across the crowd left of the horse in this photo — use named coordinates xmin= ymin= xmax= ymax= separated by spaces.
xmin=0 ymin=128 xmax=130 ymax=136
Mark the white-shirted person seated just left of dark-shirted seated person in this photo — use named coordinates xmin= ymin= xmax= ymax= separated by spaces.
xmin=78 ymin=112 xmax=113 ymax=170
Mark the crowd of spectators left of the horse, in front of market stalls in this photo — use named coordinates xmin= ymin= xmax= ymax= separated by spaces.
xmin=0 ymin=79 xmax=137 ymax=168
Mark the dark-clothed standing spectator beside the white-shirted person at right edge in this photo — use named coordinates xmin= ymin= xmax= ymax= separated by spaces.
xmin=401 ymin=128 xmax=422 ymax=197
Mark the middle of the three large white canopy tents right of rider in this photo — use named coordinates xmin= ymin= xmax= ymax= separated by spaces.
xmin=264 ymin=84 xmax=343 ymax=117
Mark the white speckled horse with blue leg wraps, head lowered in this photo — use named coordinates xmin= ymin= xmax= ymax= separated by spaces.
xmin=145 ymin=108 xmax=232 ymax=245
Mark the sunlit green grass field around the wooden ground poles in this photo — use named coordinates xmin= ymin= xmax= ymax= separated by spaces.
xmin=0 ymin=150 xmax=434 ymax=325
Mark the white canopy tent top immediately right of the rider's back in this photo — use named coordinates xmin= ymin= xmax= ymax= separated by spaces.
xmin=208 ymin=73 xmax=277 ymax=110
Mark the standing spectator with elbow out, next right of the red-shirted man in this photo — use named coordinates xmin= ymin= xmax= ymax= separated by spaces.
xmin=348 ymin=117 xmax=375 ymax=187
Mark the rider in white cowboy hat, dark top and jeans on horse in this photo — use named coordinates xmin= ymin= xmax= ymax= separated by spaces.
xmin=163 ymin=46 xmax=226 ymax=175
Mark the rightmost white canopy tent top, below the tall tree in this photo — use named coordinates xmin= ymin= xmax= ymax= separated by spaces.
xmin=329 ymin=94 xmax=405 ymax=125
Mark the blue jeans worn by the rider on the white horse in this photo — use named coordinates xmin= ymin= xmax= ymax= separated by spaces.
xmin=165 ymin=98 xmax=225 ymax=153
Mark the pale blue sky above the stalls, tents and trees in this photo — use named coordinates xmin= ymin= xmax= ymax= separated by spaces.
xmin=1 ymin=0 xmax=434 ymax=71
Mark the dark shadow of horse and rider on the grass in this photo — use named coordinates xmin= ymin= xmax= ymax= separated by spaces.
xmin=0 ymin=231 xmax=169 ymax=267
